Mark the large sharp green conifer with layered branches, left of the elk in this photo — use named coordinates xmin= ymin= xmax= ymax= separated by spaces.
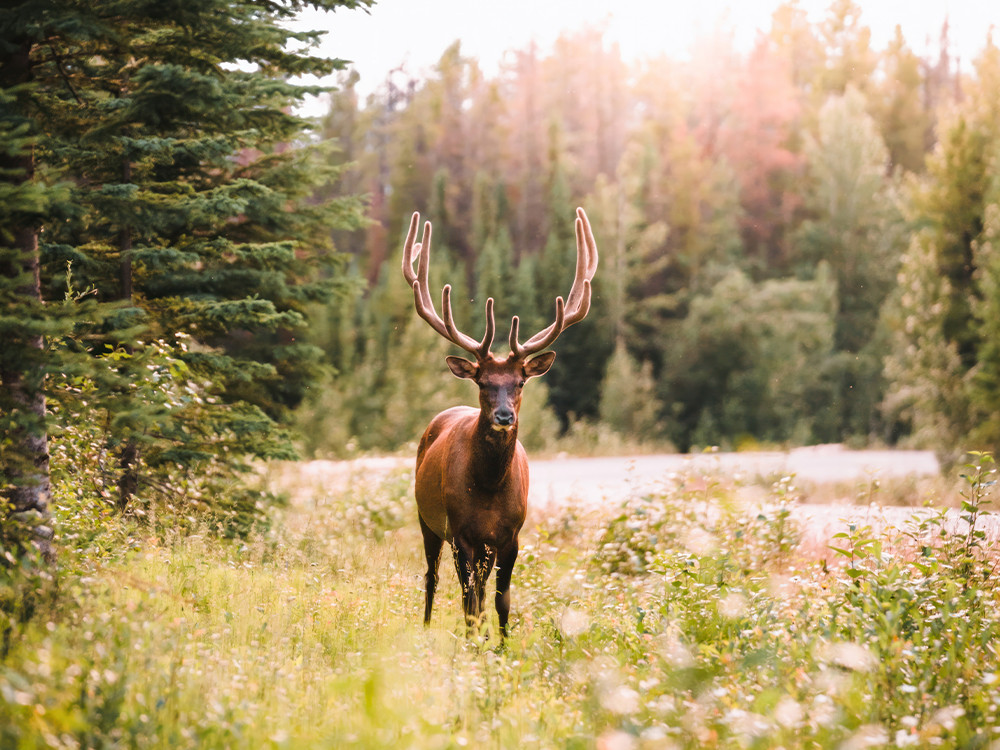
xmin=3 ymin=0 xmax=368 ymax=528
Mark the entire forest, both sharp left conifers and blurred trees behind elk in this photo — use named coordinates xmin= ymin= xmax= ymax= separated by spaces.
xmin=0 ymin=0 xmax=1000 ymax=536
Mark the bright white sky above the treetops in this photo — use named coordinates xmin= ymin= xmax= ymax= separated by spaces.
xmin=301 ymin=0 xmax=1000 ymax=114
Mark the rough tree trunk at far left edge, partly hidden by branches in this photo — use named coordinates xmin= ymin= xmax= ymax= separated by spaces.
xmin=0 ymin=39 xmax=52 ymax=557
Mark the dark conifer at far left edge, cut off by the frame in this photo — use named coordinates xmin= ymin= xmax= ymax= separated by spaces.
xmin=0 ymin=3 xmax=97 ymax=552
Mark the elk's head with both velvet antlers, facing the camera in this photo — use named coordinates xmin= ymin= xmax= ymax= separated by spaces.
xmin=403 ymin=208 xmax=597 ymax=433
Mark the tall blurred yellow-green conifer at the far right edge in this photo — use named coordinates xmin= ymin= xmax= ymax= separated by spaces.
xmin=885 ymin=43 xmax=1000 ymax=457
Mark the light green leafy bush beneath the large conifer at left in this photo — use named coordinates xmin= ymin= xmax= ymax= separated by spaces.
xmin=50 ymin=341 xmax=282 ymax=536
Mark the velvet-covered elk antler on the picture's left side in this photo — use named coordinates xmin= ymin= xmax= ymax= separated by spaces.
xmin=403 ymin=212 xmax=492 ymax=359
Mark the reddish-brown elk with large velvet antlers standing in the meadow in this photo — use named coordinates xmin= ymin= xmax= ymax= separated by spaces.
xmin=403 ymin=208 xmax=597 ymax=637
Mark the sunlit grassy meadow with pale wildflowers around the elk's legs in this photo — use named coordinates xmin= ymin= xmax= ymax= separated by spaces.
xmin=0 ymin=455 xmax=1000 ymax=750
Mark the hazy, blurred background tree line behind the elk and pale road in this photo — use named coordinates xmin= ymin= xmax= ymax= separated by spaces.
xmin=301 ymin=0 xmax=1000 ymax=464
